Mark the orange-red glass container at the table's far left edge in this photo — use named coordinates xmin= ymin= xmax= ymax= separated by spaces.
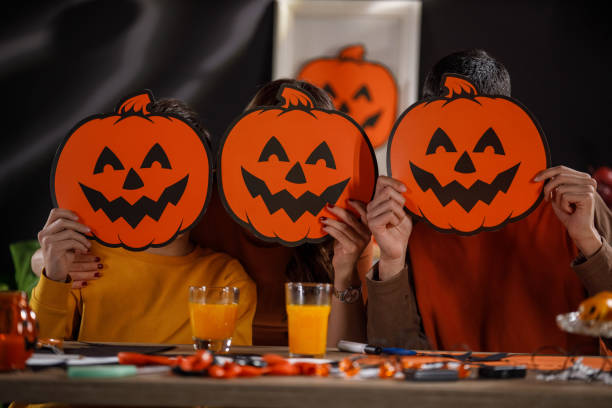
xmin=0 ymin=292 xmax=38 ymax=371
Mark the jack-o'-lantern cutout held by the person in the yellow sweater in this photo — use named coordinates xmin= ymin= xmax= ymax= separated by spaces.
xmin=51 ymin=93 xmax=212 ymax=250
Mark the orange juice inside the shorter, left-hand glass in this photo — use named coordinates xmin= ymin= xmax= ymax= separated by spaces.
xmin=189 ymin=302 xmax=238 ymax=340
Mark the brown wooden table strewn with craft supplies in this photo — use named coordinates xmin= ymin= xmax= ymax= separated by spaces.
xmin=0 ymin=346 xmax=612 ymax=408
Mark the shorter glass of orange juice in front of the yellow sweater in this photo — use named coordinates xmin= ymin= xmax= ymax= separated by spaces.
xmin=189 ymin=286 xmax=240 ymax=352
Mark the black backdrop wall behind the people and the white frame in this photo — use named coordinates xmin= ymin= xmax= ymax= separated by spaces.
xmin=0 ymin=0 xmax=612 ymax=281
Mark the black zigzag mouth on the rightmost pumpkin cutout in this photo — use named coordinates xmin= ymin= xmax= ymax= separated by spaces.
xmin=410 ymin=162 xmax=521 ymax=212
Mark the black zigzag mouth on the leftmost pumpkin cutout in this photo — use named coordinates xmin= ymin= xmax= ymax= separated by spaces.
xmin=79 ymin=174 xmax=189 ymax=228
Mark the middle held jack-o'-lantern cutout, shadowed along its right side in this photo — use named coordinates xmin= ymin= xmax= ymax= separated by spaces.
xmin=217 ymin=85 xmax=377 ymax=246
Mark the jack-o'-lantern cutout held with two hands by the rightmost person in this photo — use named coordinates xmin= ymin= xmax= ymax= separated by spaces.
xmin=387 ymin=74 xmax=550 ymax=235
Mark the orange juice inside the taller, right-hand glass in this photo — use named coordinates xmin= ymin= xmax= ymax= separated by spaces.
xmin=287 ymin=305 xmax=330 ymax=356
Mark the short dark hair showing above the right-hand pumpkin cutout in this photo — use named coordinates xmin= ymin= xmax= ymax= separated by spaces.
xmin=422 ymin=49 xmax=510 ymax=98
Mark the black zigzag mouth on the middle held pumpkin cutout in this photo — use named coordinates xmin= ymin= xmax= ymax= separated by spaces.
xmin=241 ymin=167 xmax=351 ymax=222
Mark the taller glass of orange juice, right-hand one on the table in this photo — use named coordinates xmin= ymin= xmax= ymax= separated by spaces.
xmin=285 ymin=282 xmax=332 ymax=357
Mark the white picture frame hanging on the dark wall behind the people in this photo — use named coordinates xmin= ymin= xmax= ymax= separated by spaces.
xmin=272 ymin=0 xmax=421 ymax=174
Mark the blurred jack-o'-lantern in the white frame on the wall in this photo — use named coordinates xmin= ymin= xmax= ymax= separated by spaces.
xmin=298 ymin=45 xmax=397 ymax=147
